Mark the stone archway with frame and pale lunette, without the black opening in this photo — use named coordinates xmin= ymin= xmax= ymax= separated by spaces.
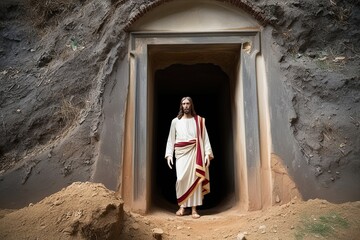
xmin=121 ymin=1 xmax=270 ymax=212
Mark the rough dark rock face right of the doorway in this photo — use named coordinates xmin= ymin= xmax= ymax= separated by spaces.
xmin=268 ymin=1 xmax=360 ymax=202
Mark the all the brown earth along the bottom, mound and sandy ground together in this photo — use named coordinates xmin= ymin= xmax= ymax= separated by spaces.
xmin=0 ymin=182 xmax=360 ymax=240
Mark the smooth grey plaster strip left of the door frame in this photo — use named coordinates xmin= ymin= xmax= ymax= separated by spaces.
xmin=92 ymin=58 xmax=129 ymax=190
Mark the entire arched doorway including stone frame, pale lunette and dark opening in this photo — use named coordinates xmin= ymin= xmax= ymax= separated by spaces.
xmin=121 ymin=1 xmax=269 ymax=212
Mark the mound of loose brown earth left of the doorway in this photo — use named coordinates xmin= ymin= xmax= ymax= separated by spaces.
xmin=0 ymin=182 xmax=124 ymax=239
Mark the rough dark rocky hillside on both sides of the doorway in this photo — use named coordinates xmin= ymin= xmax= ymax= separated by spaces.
xmin=0 ymin=0 xmax=360 ymax=207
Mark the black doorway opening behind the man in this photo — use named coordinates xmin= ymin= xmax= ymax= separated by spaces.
xmin=151 ymin=63 xmax=235 ymax=213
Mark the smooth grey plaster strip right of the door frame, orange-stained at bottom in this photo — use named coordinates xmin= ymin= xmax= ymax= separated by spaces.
xmin=262 ymin=27 xmax=306 ymax=203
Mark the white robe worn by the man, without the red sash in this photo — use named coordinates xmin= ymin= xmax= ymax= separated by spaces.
xmin=165 ymin=118 xmax=213 ymax=207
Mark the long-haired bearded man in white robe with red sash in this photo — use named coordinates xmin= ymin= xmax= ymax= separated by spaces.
xmin=165 ymin=97 xmax=214 ymax=218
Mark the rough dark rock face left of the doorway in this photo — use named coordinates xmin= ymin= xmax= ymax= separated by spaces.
xmin=0 ymin=1 xmax=116 ymax=208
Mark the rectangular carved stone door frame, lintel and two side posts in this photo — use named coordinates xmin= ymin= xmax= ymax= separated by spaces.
xmin=123 ymin=31 xmax=261 ymax=212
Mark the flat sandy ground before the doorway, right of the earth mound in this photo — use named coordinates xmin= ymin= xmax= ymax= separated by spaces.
xmin=121 ymin=200 xmax=360 ymax=240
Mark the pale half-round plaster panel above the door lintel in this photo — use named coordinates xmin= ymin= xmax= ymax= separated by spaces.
xmin=130 ymin=0 xmax=259 ymax=32
